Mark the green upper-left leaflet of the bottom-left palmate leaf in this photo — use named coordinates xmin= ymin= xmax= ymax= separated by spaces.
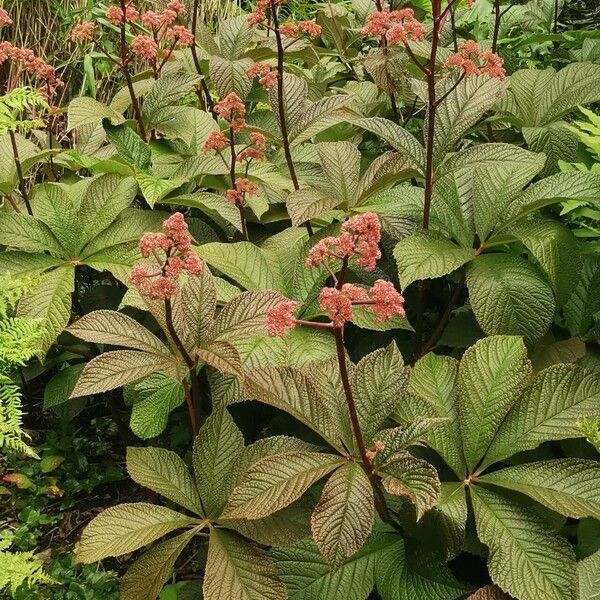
xmin=126 ymin=447 xmax=202 ymax=515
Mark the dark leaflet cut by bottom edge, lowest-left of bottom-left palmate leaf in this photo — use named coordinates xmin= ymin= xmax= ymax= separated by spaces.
xmin=120 ymin=529 xmax=196 ymax=600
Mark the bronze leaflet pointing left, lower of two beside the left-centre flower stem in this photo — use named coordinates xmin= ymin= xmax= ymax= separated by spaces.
xmin=71 ymin=350 xmax=176 ymax=398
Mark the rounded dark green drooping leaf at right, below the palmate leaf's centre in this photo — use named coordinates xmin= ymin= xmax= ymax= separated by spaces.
xmin=467 ymin=254 xmax=556 ymax=341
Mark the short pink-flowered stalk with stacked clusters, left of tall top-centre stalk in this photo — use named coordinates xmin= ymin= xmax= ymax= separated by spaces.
xmin=202 ymin=92 xmax=266 ymax=241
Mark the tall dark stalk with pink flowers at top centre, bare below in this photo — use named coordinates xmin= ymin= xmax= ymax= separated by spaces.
xmin=248 ymin=0 xmax=321 ymax=235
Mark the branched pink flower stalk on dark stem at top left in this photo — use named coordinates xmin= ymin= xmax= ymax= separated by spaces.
xmin=68 ymin=0 xmax=195 ymax=140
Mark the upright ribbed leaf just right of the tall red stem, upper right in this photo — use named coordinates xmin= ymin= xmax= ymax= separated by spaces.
xmin=432 ymin=75 xmax=505 ymax=165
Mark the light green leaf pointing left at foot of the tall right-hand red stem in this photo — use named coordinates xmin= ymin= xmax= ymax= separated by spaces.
xmin=394 ymin=231 xmax=476 ymax=289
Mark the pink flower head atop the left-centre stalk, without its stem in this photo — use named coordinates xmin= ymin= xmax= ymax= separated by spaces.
xmin=129 ymin=212 xmax=204 ymax=300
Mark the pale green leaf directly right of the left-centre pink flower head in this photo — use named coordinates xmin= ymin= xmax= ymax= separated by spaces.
xmin=198 ymin=242 xmax=285 ymax=290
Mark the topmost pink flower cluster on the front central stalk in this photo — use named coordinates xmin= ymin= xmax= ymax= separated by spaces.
xmin=306 ymin=213 xmax=381 ymax=271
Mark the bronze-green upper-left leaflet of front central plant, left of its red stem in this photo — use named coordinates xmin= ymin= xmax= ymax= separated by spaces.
xmin=244 ymin=367 xmax=339 ymax=447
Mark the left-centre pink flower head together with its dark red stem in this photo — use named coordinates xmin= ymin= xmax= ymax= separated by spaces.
xmin=129 ymin=213 xmax=204 ymax=437
